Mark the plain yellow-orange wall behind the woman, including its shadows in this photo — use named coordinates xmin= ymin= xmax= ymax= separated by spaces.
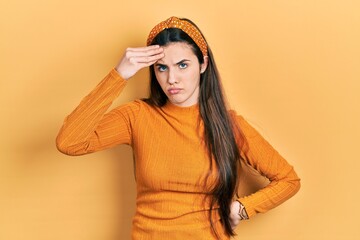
xmin=0 ymin=0 xmax=360 ymax=240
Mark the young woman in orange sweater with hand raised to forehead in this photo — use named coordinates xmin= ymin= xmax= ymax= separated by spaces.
xmin=57 ymin=17 xmax=300 ymax=240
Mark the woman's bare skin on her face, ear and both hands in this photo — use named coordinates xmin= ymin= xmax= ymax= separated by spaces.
xmin=115 ymin=42 xmax=241 ymax=228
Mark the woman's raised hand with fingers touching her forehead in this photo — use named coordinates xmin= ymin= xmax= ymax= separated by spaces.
xmin=115 ymin=45 xmax=164 ymax=79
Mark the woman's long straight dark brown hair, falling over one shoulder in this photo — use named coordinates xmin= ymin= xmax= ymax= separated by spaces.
xmin=145 ymin=18 xmax=241 ymax=238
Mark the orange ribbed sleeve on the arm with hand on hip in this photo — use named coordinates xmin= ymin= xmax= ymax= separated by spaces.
xmin=238 ymin=117 xmax=300 ymax=218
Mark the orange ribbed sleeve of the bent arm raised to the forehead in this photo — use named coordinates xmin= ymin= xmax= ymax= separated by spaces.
xmin=56 ymin=69 xmax=138 ymax=155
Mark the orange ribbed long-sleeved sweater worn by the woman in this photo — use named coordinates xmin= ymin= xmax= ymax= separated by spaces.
xmin=57 ymin=69 xmax=300 ymax=240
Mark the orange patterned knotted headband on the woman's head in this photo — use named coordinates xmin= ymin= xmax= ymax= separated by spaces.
xmin=147 ymin=17 xmax=207 ymax=56
